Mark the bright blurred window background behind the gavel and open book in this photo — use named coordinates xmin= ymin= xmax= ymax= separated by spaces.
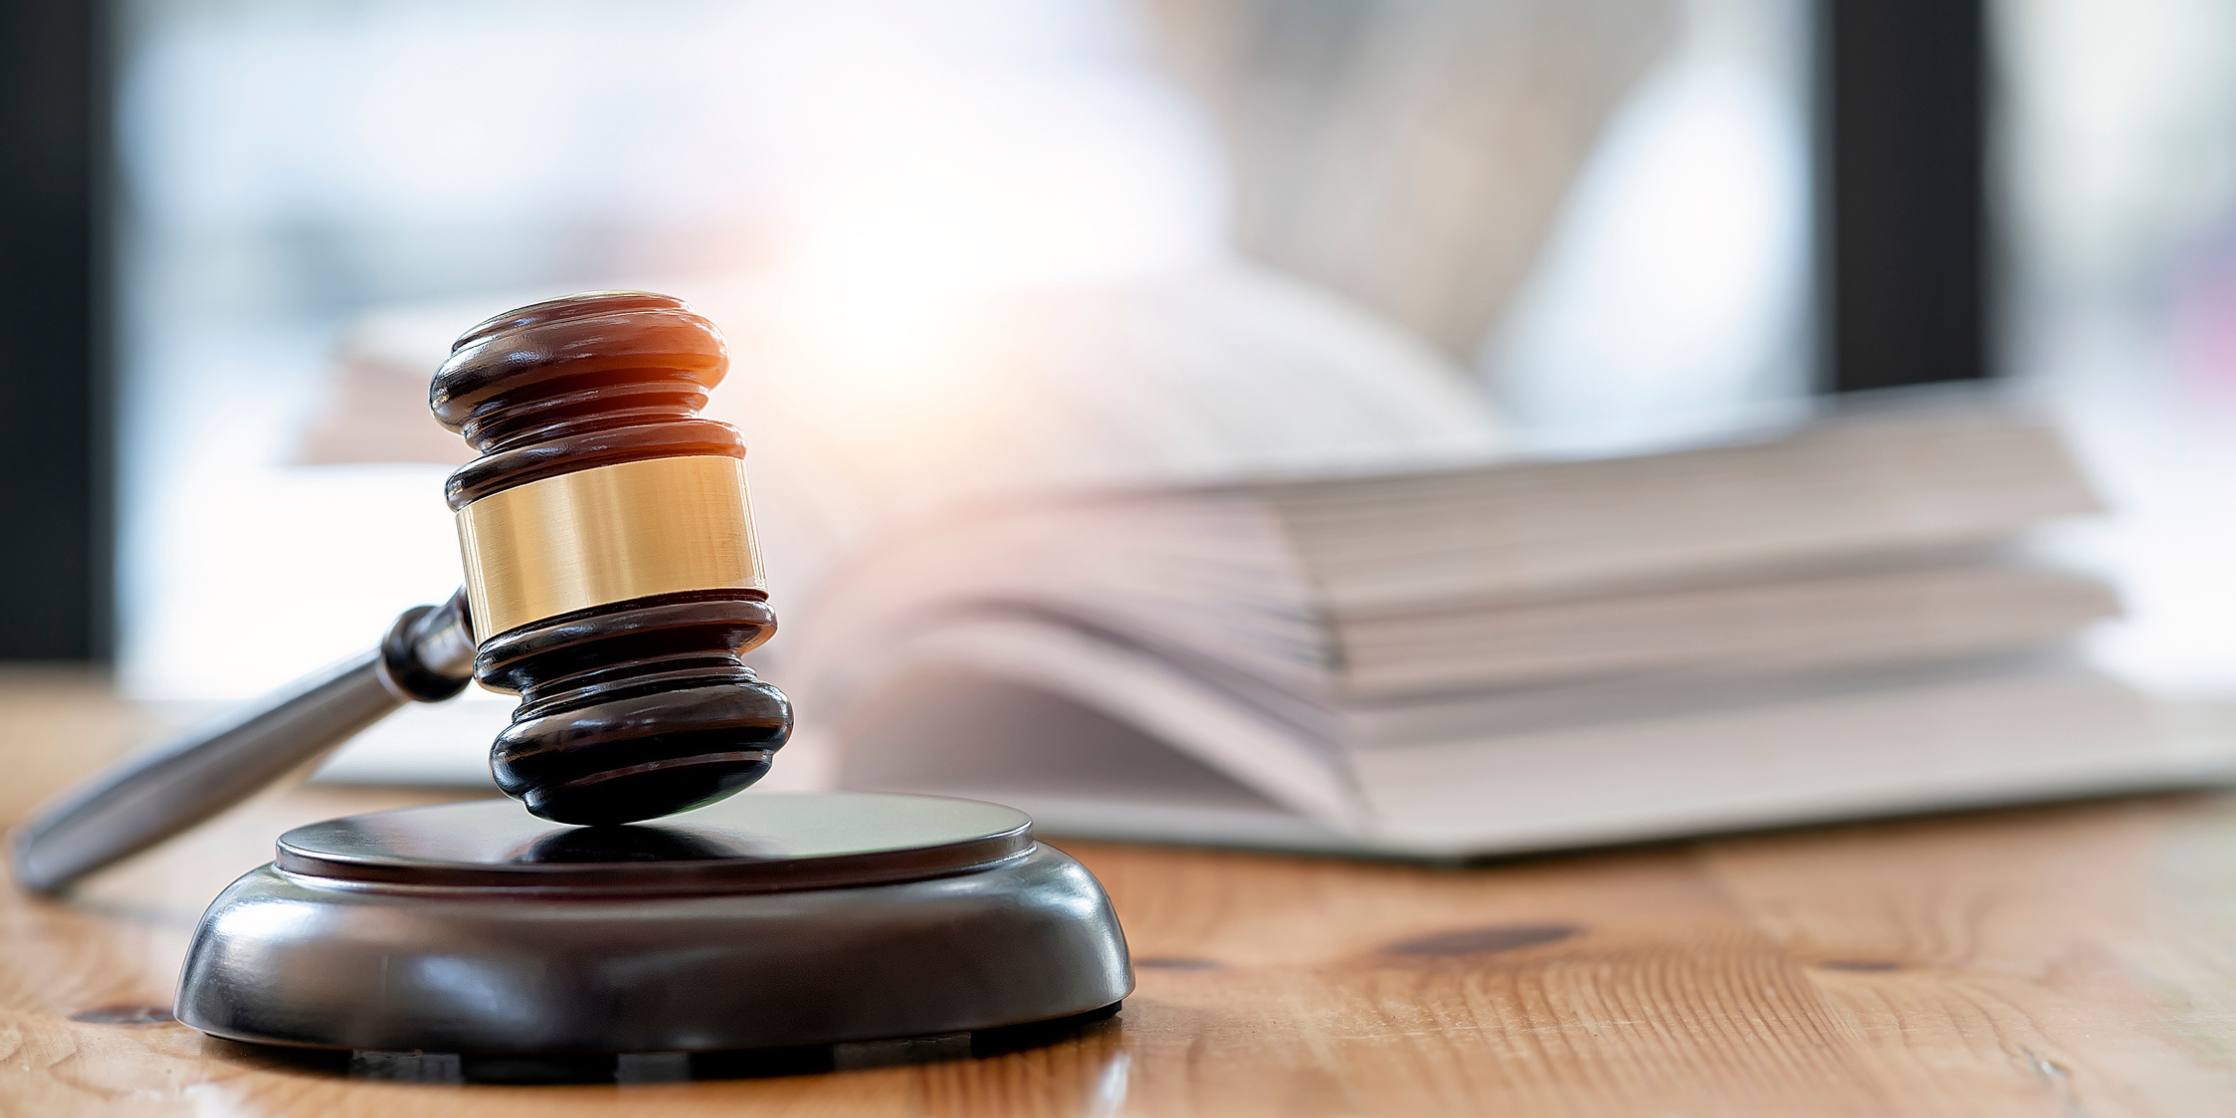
xmin=0 ymin=0 xmax=2236 ymax=804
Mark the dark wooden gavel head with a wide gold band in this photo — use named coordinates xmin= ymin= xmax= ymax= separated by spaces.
xmin=429 ymin=291 xmax=792 ymax=823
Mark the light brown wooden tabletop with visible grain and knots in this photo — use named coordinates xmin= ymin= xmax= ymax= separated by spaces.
xmin=0 ymin=673 xmax=2236 ymax=1118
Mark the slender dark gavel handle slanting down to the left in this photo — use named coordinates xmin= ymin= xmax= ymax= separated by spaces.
xmin=11 ymin=593 xmax=474 ymax=894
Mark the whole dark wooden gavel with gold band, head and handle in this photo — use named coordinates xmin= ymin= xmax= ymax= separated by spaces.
xmin=13 ymin=291 xmax=792 ymax=892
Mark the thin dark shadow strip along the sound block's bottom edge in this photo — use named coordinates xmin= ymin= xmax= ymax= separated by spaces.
xmin=203 ymin=1006 xmax=1125 ymax=1087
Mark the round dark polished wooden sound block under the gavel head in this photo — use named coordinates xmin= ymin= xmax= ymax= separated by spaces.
xmin=177 ymin=794 xmax=1134 ymax=1055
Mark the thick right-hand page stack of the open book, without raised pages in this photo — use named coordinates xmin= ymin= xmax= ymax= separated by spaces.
xmin=792 ymin=409 xmax=2227 ymax=856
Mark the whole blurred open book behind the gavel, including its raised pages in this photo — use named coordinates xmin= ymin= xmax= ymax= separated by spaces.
xmin=301 ymin=266 xmax=2227 ymax=856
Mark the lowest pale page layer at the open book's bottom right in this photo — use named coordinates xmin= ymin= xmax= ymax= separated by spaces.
xmin=1357 ymin=669 xmax=2236 ymax=854
